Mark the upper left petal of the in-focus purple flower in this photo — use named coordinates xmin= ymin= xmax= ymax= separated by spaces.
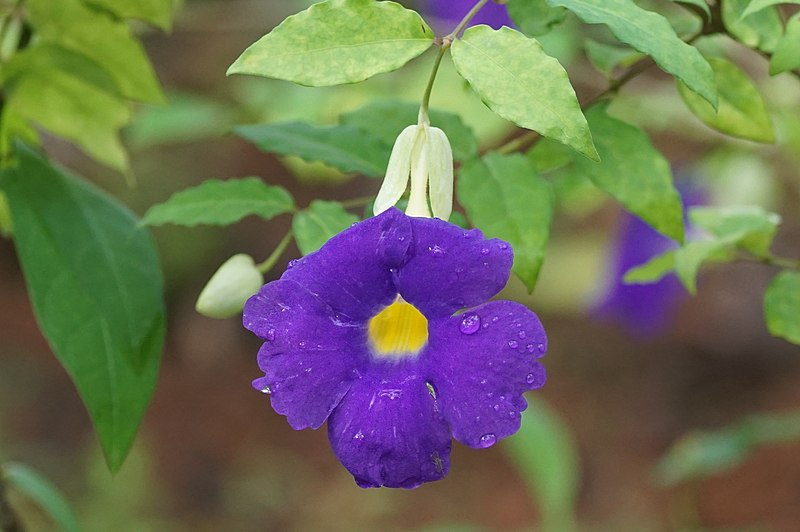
xmin=281 ymin=208 xmax=411 ymax=321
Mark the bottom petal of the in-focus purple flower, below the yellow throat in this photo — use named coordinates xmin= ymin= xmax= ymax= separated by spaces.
xmin=328 ymin=362 xmax=450 ymax=488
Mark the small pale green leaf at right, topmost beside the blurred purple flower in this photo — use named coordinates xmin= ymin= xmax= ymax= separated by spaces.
xmin=689 ymin=206 xmax=781 ymax=256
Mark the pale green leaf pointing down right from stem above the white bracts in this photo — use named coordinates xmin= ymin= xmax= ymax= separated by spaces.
xmin=452 ymin=26 xmax=597 ymax=159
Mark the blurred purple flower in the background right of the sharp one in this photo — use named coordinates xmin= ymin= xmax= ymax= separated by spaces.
xmin=591 ymin=182 xmax=705 ymax=337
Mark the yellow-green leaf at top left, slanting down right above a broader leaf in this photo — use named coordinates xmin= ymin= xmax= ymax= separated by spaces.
xmin=25 ymin=0 xmax=164 ymax=102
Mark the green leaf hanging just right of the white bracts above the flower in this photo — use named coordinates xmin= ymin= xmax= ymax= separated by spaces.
xmin=458 ymin=153 xmax=554 ymax=291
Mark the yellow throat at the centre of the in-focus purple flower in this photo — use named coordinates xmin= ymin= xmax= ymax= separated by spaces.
xmin=368 ymin=296 xmax=428 ymax=358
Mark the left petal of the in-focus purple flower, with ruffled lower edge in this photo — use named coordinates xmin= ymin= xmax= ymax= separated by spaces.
xmin=244 ymin=280 xmax=369 ymax=430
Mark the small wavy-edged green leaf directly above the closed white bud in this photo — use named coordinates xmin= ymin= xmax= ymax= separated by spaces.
xmin=142 ymin=177 xmax=294 ymax=227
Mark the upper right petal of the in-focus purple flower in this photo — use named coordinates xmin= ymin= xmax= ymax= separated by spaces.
xmin=395 ymin=218 xmax=514 ymax=319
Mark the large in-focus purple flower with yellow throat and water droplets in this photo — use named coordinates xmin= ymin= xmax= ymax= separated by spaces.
xmin=244 ymin=208 xmax=547 ymax=488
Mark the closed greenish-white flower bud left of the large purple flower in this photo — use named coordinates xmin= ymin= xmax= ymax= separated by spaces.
xmin=194 ymin=253 xmax=264 ymax=319
